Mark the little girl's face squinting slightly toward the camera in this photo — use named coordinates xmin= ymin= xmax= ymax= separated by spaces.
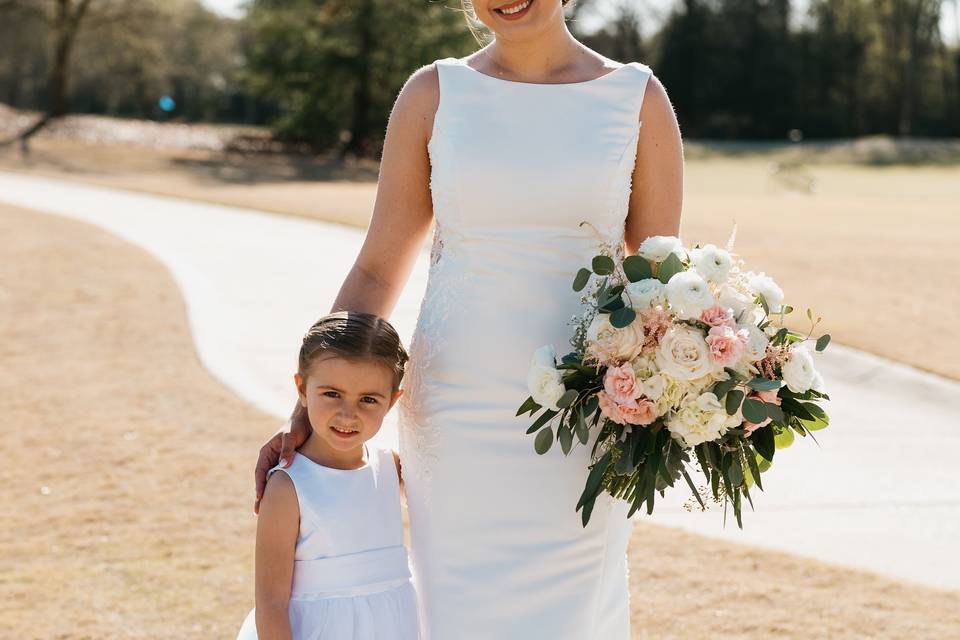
xmin=294 ymin=354 xmax=403 ymax=453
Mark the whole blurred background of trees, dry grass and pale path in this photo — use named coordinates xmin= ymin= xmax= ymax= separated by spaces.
xmin=0 ymin=0 xmax=960 ymax=639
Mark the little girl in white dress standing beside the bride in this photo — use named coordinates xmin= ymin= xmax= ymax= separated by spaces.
xmin=238 ymin=312 xmax=419 ymax=640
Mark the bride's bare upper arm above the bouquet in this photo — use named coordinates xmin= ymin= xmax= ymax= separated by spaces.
xmin=624 ymin=75 xmax=683 ymax=254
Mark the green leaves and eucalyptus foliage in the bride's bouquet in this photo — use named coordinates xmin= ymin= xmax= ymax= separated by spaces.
xmin=517 ymin=241 xmax=830 ymax=529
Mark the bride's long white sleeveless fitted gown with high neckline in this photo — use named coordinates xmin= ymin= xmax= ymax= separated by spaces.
xmin=398 ymin=58 xmax=651 ymax=640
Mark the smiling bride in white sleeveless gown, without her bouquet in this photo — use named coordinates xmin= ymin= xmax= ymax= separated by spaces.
xmin=251 ymin=0 xmax=683 ymax=640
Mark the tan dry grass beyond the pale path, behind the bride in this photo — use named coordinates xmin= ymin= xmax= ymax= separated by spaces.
xmin=0 ymin=135 xmax=960 ymax=379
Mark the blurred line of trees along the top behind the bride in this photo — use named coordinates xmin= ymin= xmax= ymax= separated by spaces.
xmin=0 ymin=0 xmax=960 ymax=155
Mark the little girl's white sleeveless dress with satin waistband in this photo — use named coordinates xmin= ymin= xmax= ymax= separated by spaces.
xmin=237 ymin=442 xmax=419 ymax=640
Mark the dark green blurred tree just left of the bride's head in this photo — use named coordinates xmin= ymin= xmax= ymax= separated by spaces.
xmin=245 ymin=0 xmax=475 ymax=155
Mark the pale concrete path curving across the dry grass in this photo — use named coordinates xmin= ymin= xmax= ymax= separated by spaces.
xmin=0 ymin=172 xmax=960 ymax=589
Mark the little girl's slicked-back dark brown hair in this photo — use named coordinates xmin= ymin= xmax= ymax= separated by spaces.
xmin=298 ymin=311 xmax=409 ymax=391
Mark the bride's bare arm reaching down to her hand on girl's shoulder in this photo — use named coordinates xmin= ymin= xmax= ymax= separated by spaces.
xmin=253 ymin=64 xmax=440 ymax=512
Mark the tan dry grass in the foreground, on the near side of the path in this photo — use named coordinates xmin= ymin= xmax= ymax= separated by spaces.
xmin=0 ymin=207 xmax=960 ymax=640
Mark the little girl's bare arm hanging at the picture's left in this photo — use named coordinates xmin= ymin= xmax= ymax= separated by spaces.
xmin=256 ymin=473 xmax=300 ymax=640
